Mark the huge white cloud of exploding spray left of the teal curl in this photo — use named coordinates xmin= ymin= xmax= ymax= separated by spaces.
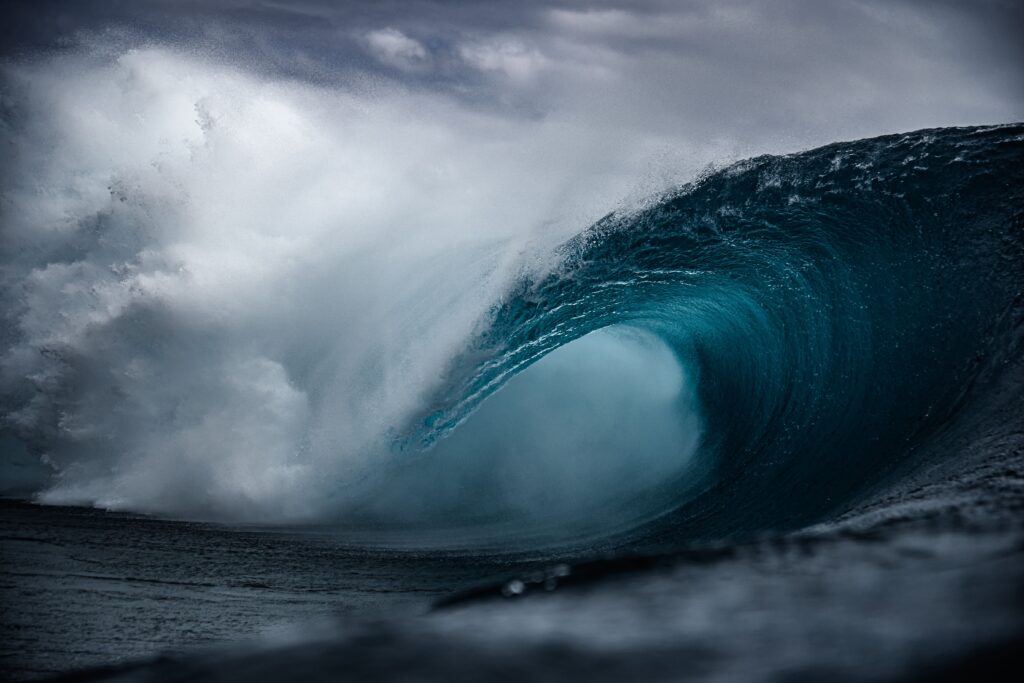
xmin=2 ymin=49 xmax=700 ymax=520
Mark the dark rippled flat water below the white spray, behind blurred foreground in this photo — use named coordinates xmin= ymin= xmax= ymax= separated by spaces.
xmin=0 ymin=501 xmax=552 ymax=679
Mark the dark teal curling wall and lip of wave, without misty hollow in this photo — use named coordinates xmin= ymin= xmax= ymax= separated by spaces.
xmin=407 ymin=124 xmax=1024 ymax=545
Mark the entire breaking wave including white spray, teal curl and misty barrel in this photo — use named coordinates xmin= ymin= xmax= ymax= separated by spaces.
xmin=0 ymin=50 xmax=1024 ymax=545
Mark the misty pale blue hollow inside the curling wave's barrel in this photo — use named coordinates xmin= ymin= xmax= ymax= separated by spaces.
xmin=344 ymin=325 xmax=701 ymax=548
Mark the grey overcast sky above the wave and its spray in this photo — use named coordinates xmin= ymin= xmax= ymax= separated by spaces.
xmin=0 ymin=0 xmax=1024 ymax=154
